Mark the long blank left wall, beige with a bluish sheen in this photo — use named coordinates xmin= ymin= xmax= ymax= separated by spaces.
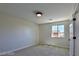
xmin=0 ymin=14 xmax=39 ymax=53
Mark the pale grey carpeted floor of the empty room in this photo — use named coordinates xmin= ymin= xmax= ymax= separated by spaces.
xmin=5 ymin=45 xmax=69 ymax=56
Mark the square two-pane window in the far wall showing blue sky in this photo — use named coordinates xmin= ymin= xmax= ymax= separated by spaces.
xmin=51 ymin=25 xmax=64 ymax=38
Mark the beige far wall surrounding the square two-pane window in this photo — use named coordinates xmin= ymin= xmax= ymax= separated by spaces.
xmin=39 ymin=21 xmax=69 ymax=48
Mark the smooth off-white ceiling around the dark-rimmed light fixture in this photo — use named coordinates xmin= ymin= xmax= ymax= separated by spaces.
xmin=0 ymin=3 xmax=77 ymax=24
